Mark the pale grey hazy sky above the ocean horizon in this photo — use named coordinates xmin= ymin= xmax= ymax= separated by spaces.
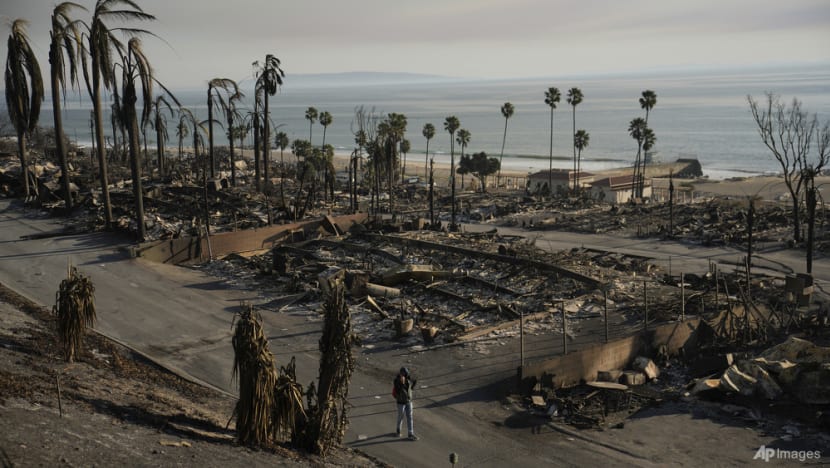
xmin=0 ymin=0 xmax=830 ymax=88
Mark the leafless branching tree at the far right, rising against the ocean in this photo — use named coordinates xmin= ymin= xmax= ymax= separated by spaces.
xmin=747 ymin=92 xmax=827 ymax=242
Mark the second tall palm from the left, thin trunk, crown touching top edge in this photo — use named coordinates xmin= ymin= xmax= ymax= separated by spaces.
xmin=49 ymin=2 xmax=86 ymax=213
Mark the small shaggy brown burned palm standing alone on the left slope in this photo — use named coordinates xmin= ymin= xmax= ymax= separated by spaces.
xmin=52 ymin=267 xmax=95 ymax=362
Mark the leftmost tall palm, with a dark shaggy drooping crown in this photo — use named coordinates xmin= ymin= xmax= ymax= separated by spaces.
xmin=5 ymin=19 xmax=43 ymax=197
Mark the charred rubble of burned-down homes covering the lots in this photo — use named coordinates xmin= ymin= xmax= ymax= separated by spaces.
xmin=0 ymin=151 xmax=830 ymax=436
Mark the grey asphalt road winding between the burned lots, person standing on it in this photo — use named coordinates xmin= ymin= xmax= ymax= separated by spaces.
xmin=0 ymin=200 xmax=827 ymax=466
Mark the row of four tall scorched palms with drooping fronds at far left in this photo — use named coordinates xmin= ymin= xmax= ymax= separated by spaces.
xmin=5 ymin=0 xmax=155 ymax=232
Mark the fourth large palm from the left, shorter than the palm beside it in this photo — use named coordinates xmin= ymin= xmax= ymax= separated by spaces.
xmin=113 ymin=37 xmax=153 ymax=241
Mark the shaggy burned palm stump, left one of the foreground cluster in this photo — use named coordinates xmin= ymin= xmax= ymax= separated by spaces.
xmin=232 ymin=305 xmax=278 ymax=446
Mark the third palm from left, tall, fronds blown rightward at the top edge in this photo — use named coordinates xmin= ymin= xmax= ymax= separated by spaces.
xmin=84 ymin=0 xmax=156 ymax=228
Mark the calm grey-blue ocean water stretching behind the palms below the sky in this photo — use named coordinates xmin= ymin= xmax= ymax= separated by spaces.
xmin=17 ymin=66 xmax=830 ymax=179
